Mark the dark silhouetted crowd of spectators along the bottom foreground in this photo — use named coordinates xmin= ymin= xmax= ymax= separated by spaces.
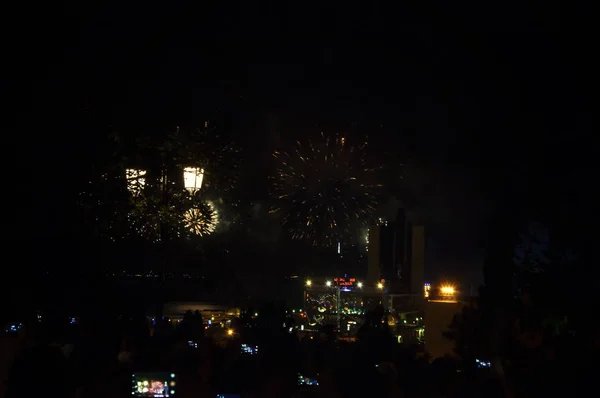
xmin=3 ymin=305 xmax=584 ymax=398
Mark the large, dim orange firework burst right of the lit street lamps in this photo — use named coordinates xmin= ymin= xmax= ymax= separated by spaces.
xmin=271 ymin=134 xmax=381 ymax=246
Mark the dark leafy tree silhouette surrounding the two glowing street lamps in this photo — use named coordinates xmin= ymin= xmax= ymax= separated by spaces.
xmin=79 ymin=124 xmax=241 ymax=243
